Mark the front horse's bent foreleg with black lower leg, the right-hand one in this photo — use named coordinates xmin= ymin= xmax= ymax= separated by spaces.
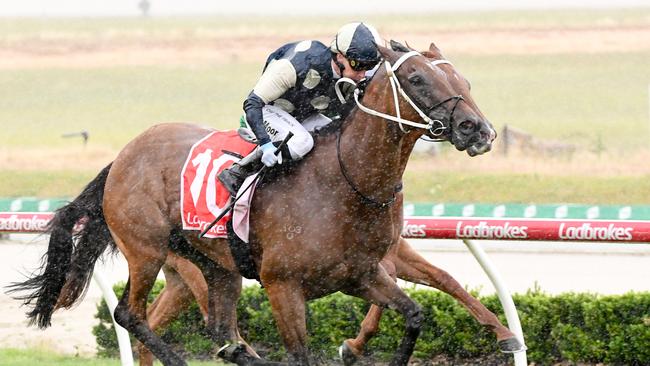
xmin=350 ymin=267 xmax=424 ymax=366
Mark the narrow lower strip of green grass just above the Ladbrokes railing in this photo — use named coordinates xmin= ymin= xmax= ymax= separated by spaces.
xmin=5 ymin=170 xmax=650 ymax=205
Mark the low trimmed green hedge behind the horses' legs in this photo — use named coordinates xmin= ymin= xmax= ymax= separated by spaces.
xmin=93 ymin=282 xmax=650 ymax=365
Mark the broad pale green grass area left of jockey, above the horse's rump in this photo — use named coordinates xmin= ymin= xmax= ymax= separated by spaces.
xmin=0 ymin=64 xmax=259 ymax=149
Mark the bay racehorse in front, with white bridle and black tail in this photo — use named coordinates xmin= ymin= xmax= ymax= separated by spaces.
xmin=10 ymin=41 xmax=495 ymax=365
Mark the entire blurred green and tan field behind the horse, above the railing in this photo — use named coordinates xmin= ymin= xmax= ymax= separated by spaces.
xmin=0 ymin=8 xmax=650 ymax=204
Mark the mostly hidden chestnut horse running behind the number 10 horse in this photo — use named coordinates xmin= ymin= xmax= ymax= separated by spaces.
xmin=138 ymin=44 xmax=524 ymax=365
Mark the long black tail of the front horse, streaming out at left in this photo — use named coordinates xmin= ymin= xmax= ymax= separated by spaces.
xmin=9 ymin=163 xmax=115 ymax=328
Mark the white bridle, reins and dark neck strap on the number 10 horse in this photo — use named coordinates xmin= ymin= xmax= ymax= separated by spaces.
xmin=335 ymin=51 xmax=464 ymax=208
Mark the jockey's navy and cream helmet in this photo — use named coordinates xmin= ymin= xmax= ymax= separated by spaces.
xmin=330 ymin=22 xmax=382 ymax=71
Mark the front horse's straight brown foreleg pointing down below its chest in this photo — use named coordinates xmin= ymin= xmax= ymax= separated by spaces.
xmin=265 ymin=281 xmax=309 ymax=365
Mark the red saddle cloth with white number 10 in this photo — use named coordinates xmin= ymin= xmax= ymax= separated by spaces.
xmin=181 ymin=131 xmax=256 ymax=238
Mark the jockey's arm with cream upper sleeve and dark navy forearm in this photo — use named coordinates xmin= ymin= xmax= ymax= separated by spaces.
xmin=244 ymin=59 xmax=297 ymax=146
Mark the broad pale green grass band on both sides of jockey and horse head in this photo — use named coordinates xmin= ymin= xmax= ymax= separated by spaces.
xmin=0 ymin=52 xmax=650 ymax=149
